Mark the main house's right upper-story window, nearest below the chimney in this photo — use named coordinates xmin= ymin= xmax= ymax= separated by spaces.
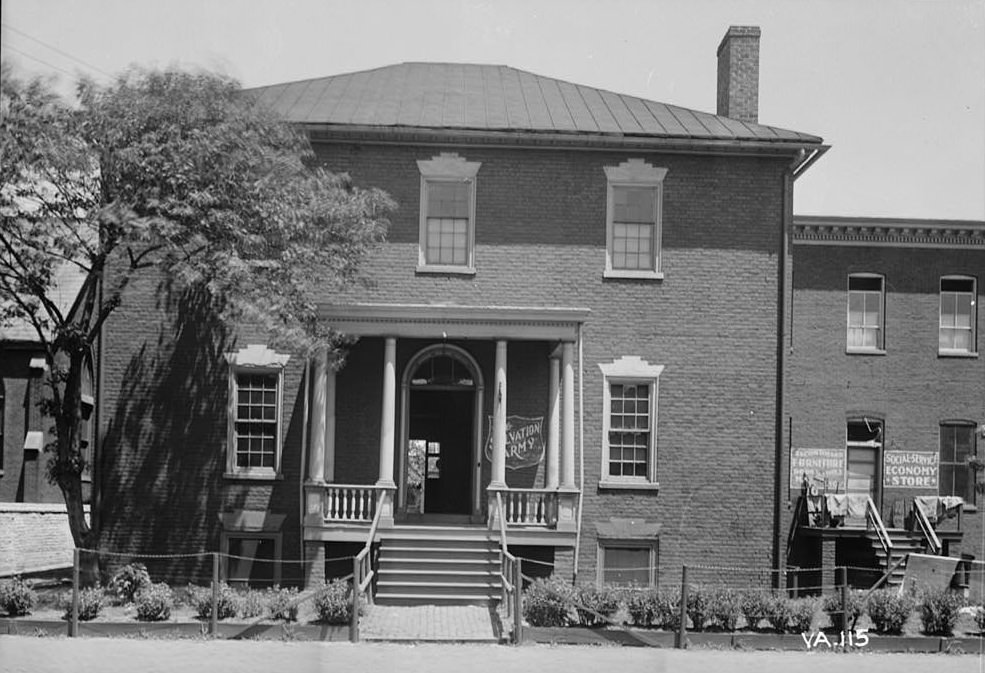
xmin=604 ymin=159 xmax=667 ymax=278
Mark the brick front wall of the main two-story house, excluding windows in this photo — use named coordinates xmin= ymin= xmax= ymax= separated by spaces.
xmin=98 ymin=138 xmax=785 ymax=584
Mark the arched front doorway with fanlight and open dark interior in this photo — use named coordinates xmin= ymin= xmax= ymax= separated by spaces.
xmin=399 ymin=344 xmax=483 ymax=516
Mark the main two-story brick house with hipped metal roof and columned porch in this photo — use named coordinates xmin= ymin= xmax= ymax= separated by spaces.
xmin=92 ymin=27 xmax=826 ymax=600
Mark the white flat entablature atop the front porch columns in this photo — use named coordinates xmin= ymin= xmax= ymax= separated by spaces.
xmin=319 ymin=304 xmax=591 ymax=341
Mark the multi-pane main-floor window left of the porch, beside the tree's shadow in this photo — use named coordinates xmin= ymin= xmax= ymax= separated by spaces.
xmin=226 ymin=345 xmax=290 ymax=478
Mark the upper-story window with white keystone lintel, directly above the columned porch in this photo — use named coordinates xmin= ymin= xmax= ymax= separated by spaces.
xmin=417 ymin=152 xmax=482 ymax=274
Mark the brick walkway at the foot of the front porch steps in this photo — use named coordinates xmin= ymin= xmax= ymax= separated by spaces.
xmin=359 ymin=605 xmax=498 ymax=643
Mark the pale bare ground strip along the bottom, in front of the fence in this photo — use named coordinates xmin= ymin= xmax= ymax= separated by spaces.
xmin=0 ymin=636 xmax=985 ymax=673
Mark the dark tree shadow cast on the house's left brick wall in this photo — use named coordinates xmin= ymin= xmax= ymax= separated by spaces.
xmin=99 ymin=290 xmax=233 ymax=583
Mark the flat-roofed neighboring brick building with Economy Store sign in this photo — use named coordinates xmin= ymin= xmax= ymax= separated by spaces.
xmin=784 ymin=216 xmax=985 ymax=588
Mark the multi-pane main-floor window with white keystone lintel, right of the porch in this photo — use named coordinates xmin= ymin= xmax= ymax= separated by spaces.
xmin=599 ymin=356 xmax=663 ymax=488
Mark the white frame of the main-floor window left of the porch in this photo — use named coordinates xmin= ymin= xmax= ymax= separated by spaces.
xmin=226 ymin=344 xmax=290 ymax=479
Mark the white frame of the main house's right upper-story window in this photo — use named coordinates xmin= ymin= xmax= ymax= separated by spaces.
xmin=603 ymin=159 xmax=667 ymax=280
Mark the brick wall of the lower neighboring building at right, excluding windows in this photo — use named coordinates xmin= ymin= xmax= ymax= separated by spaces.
xmin=784 ymin=245 xmax=985 ymax=558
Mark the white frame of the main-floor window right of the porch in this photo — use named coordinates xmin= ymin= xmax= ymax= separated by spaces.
xmin=599 ymin=355 xmax=664 ymax=490
